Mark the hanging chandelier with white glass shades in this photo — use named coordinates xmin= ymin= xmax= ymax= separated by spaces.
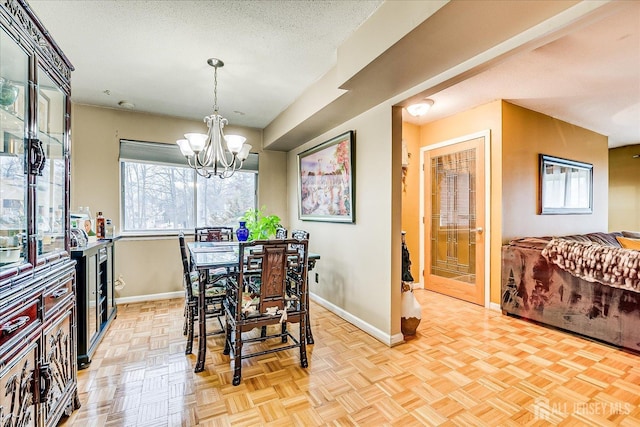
xmin=176 ymin=58 xmax=251 ymax=178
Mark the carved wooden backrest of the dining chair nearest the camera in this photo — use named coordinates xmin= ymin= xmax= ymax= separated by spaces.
xmin=236 ymin=239 xmax=308 ymax=315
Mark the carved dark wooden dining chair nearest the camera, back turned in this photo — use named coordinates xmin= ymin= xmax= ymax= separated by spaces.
xmin=224 ymin=239 xmax=308 ymax=385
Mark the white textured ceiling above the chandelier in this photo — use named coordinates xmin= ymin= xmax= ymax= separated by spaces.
xmin=29 ymin=0 xmax=382 ymax=128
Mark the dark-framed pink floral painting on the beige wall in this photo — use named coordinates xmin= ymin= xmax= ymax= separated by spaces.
xmin=298 ymin=131 xmax=355 ymax=223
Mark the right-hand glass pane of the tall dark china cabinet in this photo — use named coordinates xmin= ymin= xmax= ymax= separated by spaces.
xmin=35 ymin=68 xmax=66 ymax=256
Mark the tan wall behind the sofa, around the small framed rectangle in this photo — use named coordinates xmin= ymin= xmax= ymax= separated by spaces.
xmin=502 ymin=102 xmax=609 ymax=242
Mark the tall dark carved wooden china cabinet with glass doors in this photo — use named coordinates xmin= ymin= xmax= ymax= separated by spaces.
xmin=0 ymin=0 xmax=80 ymax=426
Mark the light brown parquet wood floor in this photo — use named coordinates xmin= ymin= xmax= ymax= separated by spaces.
xmin=63 ymin=290 xmax=640 ymax=427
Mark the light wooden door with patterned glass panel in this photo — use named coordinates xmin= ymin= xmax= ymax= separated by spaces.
xmin=424 ymin=136 xmax=485 ymax=305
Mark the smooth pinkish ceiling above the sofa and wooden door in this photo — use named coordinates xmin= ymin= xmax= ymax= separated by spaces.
xmin=405 ymin=1 xmax=640 ymax=147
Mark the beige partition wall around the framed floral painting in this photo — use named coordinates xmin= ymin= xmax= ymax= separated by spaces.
xmin=287 ymin=104 xmax=401 ymax=342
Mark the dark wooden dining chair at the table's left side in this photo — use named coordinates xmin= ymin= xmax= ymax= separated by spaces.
xmin=178 ymin=232 xmax=227 ymax=354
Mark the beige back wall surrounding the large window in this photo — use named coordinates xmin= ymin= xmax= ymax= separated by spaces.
xmin=71 ymin=104 xmax=288 ymax=297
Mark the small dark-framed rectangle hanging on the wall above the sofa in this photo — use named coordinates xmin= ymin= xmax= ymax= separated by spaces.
xmin=538 ymin=154 xmax=593 ymax=215
